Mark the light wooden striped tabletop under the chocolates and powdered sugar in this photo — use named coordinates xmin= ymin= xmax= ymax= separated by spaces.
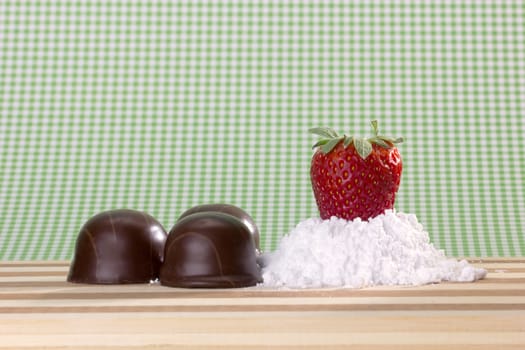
xmin=0 ymin=258 xmax=525 ymax=350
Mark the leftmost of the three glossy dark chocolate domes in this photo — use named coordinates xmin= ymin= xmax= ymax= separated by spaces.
xmin=67 ymin=209 xmax=167 ymax=284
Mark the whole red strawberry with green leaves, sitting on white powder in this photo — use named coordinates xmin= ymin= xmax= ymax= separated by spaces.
xmin=309 ymin=120 xmax=403 ymax=220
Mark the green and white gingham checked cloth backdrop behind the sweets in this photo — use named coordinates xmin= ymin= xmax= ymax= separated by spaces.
xmin=0 ymin=0 xmax=525 ymax=260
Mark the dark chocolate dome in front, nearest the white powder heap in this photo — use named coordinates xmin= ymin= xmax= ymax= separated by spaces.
xmin=160 ymin=211 xmax=262 ymax=288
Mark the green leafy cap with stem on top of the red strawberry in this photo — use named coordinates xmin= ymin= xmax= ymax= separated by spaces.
xmin=308 ymin=120 xmax=403 ymax=159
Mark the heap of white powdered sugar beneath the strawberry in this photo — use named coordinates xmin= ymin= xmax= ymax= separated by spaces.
xmin=262 ymin=210 xmax=487 ymax=288
